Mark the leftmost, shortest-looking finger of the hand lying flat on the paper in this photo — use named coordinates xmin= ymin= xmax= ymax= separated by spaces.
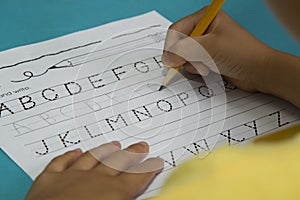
xmin=44 ymin=149 xmax=82 ymax=172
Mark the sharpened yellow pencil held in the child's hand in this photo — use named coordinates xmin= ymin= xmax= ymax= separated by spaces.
xmin=158 ymin=0 xmax=225 ymax=91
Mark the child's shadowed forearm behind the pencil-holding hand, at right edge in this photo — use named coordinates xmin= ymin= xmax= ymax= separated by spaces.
xmin=259 ymin=50 xmax=300 ymax=108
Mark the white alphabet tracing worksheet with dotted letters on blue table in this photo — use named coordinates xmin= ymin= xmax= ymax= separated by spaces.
xmin=0 ymin=11 xmax=300 ymax=197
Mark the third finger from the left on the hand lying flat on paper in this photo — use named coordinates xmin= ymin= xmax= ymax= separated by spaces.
xmin=95 ymin=142 xmax=149 ymax=176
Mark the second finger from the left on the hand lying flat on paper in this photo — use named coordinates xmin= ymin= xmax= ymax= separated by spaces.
xmin=69 ymin=141 xmax=121 ymax=170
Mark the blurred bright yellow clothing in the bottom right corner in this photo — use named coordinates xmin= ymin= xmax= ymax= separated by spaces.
xmin=155 ymin=125 xmax=300 ymax=200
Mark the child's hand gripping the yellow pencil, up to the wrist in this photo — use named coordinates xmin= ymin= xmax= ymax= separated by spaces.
xmin=163 ymin=8 xmax=272 ymax=91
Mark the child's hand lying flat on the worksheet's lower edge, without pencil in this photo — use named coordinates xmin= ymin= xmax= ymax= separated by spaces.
xmin=26 ymin=142 xmax=163 ymax=200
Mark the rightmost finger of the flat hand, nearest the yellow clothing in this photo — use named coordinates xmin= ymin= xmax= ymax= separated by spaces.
xmin=119 ymin=158 xmax=164 ymax=197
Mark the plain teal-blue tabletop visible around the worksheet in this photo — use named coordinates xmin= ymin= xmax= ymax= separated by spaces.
xmin=0 ymin=0 xmax=300 ymax=199
